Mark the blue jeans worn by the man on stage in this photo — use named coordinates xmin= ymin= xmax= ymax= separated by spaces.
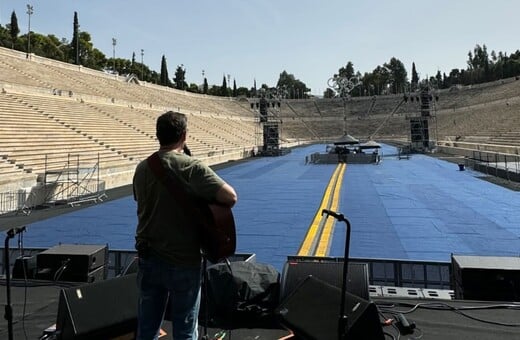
xmin=137 ymin=255 xmax=201 ymax=340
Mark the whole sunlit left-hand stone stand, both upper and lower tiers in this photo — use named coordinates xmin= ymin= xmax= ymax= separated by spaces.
xmin=0 ymin=48 xmax=258 ymax=189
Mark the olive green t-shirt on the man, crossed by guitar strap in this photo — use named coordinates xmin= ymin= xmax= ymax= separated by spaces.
xmin=133 ymin=151 xmax=224 ymax=266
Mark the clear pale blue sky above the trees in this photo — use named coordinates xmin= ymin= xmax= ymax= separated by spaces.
xmin=0 ymin=0 xmax=520 ymax=94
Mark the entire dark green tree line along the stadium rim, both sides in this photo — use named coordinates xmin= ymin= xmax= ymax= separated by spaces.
xmin=0 ymin=11 xmax=520 ymax=99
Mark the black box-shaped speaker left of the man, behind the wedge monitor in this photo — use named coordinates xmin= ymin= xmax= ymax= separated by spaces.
xmin=36 ymin=244 xmax=108 ymax=282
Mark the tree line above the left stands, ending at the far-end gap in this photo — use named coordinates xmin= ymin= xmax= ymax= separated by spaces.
xmin=0 ymin=11 xmax=310 ymax=98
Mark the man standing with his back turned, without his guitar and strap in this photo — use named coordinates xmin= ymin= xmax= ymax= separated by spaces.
xmin=133 ymin=111 xmax=237 ymax=340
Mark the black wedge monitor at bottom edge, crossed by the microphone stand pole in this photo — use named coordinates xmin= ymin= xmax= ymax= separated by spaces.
xmin=275 ymin=276 xmax=385 ymax=340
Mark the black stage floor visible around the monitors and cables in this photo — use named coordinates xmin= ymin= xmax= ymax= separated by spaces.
xmin=0 ymin=280 xmax=520 ymax=340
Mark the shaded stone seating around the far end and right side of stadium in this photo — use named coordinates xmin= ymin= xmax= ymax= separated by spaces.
xmin=280 ymin=78 xmax=520 ymax=145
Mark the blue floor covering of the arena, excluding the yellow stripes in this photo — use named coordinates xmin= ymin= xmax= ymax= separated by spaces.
xmin=24 ymin=145 xmax=520 ymax=270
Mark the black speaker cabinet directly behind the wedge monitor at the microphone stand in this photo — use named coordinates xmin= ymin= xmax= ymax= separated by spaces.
xmin=281 ymin=260 xmax=370 ymax=300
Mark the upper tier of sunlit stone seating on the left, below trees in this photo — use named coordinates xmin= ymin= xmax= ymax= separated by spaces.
xmin=0 ymin=48 xmax=251 ymax=117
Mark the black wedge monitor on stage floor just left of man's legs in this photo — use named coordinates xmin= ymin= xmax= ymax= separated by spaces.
xmin=56 ymin=274 xmax=138 ymax=340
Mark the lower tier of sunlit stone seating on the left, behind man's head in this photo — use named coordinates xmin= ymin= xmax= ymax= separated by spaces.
xmin=0 ymin=89 xmax=255 ymax=181
